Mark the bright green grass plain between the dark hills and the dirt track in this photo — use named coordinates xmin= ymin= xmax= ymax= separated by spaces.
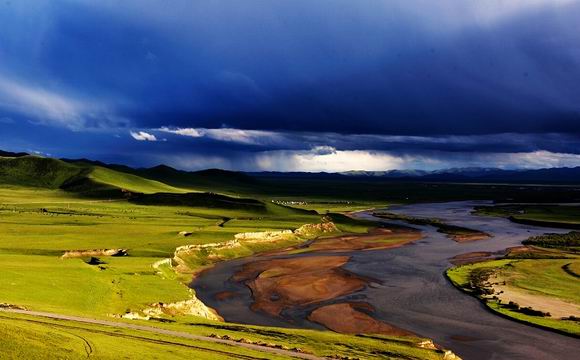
xmin=0 ymin=187 xmax=368 ymax=315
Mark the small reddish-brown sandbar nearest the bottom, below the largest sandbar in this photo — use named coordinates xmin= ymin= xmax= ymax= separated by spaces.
xmin=308 ymin=303 xmax=417 ymax=336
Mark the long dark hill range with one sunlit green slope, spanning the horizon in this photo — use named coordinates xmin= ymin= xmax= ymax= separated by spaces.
xmin=0 ymin=149 xmax=580 ymax=206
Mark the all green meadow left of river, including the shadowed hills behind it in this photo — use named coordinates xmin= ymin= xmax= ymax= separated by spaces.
xmin=0 ymin=157 xmax=454 ymax=359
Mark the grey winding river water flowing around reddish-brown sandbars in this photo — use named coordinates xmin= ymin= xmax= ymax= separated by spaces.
xmin=191 ymin=202 xmax=580 ymax=360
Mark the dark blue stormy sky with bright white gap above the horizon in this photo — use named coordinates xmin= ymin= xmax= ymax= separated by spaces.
xmin=0 ymin=0 xmax=580 ymax=171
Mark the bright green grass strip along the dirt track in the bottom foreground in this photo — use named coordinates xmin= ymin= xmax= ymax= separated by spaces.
xmin=0 ymin=313 xmax=443 ymax=360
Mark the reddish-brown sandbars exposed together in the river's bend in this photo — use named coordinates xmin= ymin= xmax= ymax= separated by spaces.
xmin=232 ymin=227 xmax=422 ymax=336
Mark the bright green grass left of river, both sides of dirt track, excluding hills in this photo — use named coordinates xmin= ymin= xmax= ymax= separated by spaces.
xmin=0 ymin=187 xmax=454 ymax=359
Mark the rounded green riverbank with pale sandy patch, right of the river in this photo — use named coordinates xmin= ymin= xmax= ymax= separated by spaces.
xmin=445 ymin=246 xmax=580 ymax=338
